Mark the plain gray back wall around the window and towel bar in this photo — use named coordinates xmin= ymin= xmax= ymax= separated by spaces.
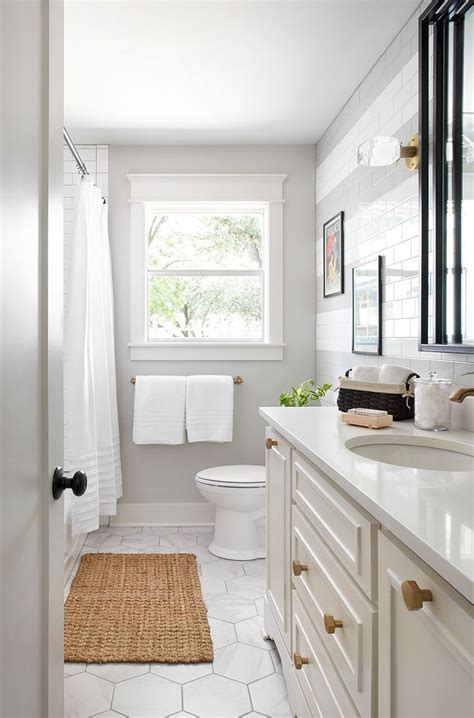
xmin=109 ymin=145 xmax=315 ymax=503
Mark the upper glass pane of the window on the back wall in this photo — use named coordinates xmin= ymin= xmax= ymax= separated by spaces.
xmin=147 ymin=212 xmax=263 ymax=270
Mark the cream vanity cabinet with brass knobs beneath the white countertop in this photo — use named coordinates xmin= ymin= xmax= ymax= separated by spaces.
xmin=264 ymin=410 xmax=474 ymax=718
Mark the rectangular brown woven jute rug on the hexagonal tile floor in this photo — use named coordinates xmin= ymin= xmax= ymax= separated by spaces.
xmin=64 ymin=553 xmax=213 ymax=663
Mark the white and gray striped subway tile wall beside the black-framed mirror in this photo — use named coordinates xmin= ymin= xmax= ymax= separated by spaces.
xmin=316 ymin=3 xmax=474 ymax=431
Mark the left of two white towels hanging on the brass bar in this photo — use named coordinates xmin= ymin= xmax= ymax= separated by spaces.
xmin=133 ymin=376 xmax=186 ymax=444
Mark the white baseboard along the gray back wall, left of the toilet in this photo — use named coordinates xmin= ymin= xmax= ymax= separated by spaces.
xmin=110 ymin=503 xmax=215 ymax=526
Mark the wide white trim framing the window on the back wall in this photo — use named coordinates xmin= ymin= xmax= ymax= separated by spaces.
xmin=128 ymin=174 xmax=286 ymax=361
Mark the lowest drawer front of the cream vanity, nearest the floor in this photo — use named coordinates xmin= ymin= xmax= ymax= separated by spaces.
xmin=292 ymin=591 xmax=359 ymax=718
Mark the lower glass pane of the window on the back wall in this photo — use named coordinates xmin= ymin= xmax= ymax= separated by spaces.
xmin=148 ymin=276 xmax=263 ymax=340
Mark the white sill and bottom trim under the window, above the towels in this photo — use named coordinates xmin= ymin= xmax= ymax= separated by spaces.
xmin=128 ymin=342 xmax=285 ymax=361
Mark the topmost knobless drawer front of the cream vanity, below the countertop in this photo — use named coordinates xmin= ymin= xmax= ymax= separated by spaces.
xmin=292 ymin=452 xmax=379 ymax=601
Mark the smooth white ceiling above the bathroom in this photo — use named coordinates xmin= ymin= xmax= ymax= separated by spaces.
xmin=65 ymin=0 xmax=419 ymax=144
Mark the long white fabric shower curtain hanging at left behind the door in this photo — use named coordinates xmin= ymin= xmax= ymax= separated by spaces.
xmin=64 ymin=177 xmax=122 ymax=535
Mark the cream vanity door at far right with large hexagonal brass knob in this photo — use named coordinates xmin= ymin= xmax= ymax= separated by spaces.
xmin=379 ymin=532 xmax=474 ymax=718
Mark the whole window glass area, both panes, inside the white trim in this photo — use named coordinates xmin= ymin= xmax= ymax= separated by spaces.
xmin=146 ymin=205 xmax=267 ymax=341
